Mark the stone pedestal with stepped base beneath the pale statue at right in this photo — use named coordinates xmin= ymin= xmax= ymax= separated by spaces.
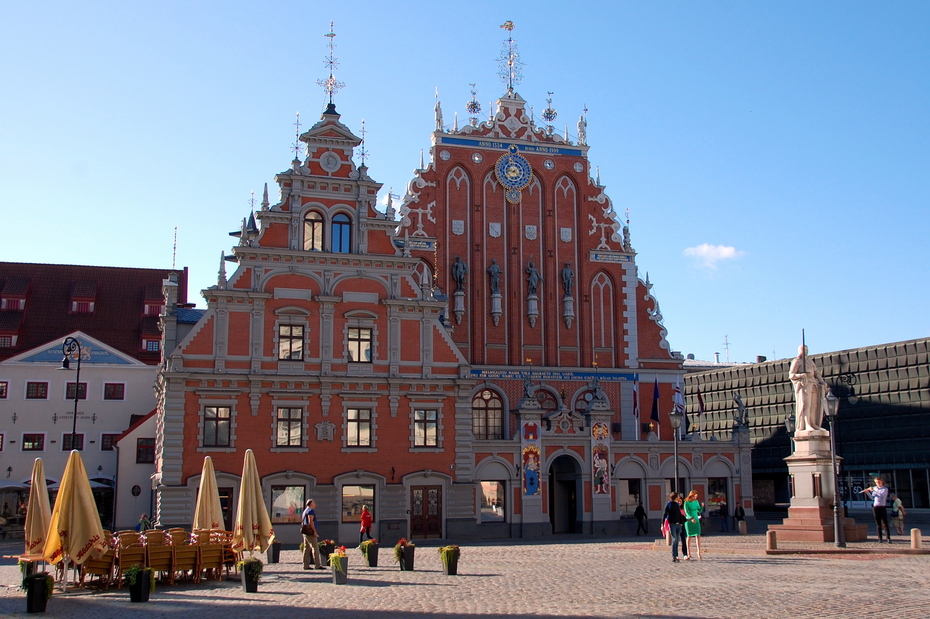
xmin=769 ymin=430 xmax=867 ymax=542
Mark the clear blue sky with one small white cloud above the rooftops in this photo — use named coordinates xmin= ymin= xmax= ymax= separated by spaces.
xmin=0 ymin=0 xmax=930 ymax=361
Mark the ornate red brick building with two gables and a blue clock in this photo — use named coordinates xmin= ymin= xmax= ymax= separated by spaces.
xmin=156 ymin=74 xmax=751 ymax=543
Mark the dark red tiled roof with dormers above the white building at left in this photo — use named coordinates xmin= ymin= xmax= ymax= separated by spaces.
xmin=0 ymin=262 xmax=187 ymax=365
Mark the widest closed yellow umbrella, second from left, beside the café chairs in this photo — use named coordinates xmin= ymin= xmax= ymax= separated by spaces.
xmin=42 ymin=450 xmax=107 ymax=565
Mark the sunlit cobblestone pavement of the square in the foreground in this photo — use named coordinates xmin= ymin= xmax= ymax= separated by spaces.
xmin=0 ymin=531 xmax=930 ymax=619
